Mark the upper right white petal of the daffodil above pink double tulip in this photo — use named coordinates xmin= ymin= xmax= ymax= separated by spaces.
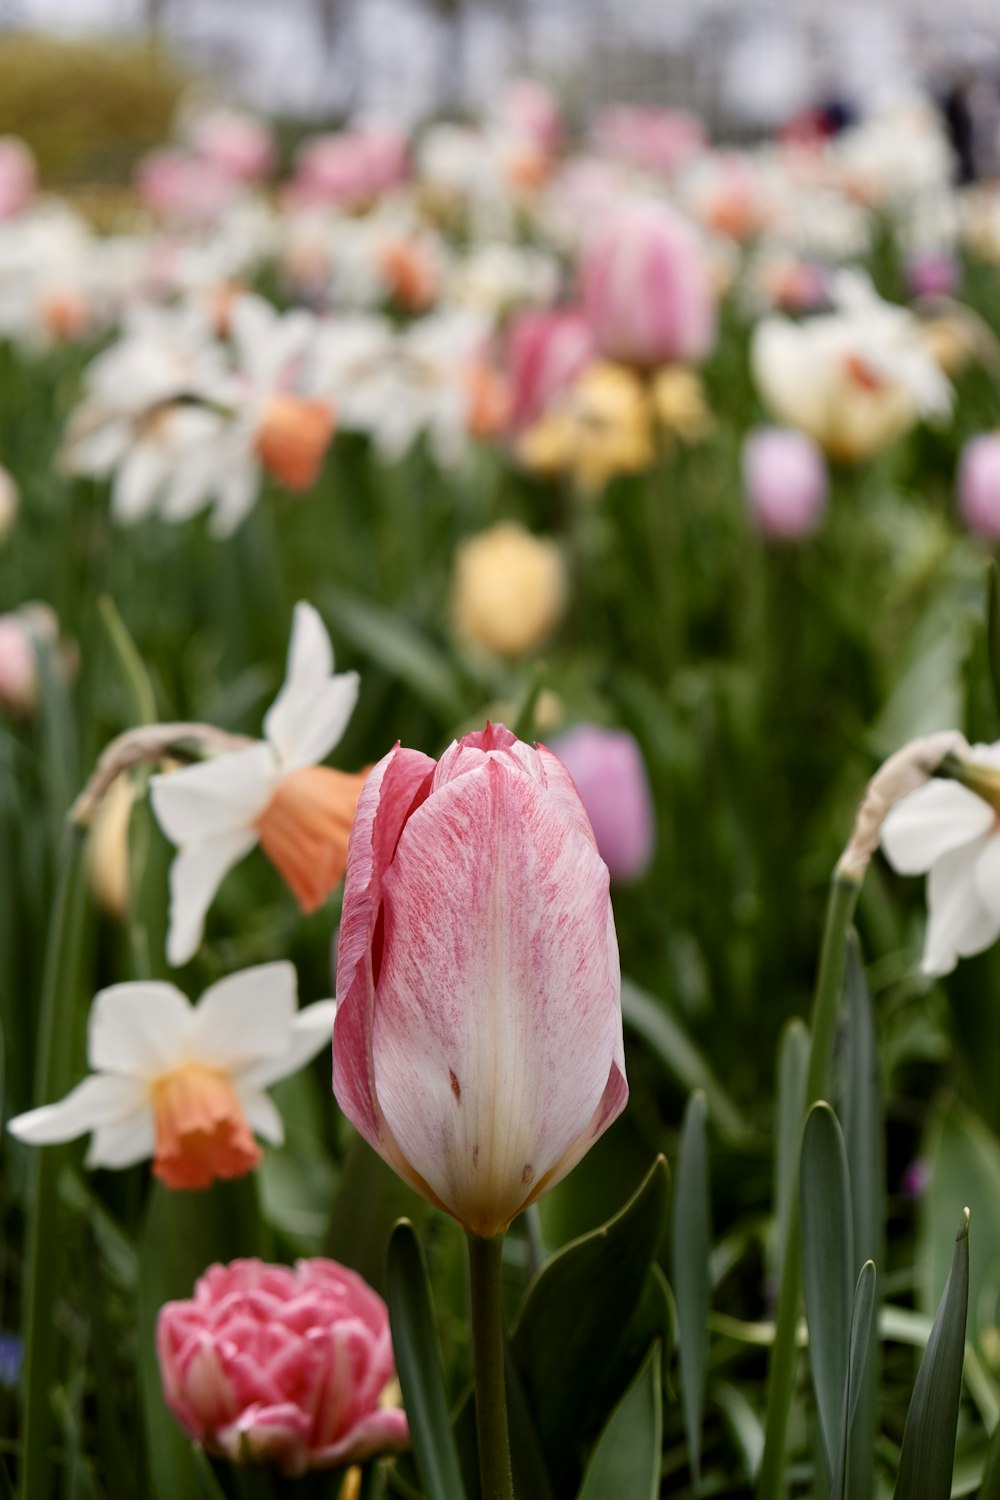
xmin=192 ymin=963 xmax=298 ymax=1073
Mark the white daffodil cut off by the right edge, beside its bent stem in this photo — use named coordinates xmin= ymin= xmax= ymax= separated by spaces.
xmin=882 ymin=743 xmax=1000 ymax=975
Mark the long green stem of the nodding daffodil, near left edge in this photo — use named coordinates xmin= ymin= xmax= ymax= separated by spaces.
xmin=21 ymin=824 xmax=85 ymax=1500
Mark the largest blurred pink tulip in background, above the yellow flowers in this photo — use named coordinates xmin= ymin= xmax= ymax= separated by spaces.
xmin=582 ymin=201 xmax=715 ymax=368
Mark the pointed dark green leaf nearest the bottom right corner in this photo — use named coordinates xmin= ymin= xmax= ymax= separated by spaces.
xmin=894 ymin=1209 xmax=969 ymax=1500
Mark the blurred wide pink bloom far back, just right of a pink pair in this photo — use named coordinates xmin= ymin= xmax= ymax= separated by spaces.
xmin=289 ymin=126 xmax=409 ymax=207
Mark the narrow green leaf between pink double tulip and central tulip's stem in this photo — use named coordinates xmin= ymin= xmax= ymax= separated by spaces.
xmin=387 ymin=1220 xmax=465 ymax=1500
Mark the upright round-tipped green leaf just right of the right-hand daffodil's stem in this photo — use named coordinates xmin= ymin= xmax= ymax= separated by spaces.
xmin=799 ymin=1103 xmax=855 ymax=1479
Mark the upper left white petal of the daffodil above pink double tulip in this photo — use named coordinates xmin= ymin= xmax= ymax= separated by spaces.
xmin=87 ymin=980 xmax=193 ymax=1079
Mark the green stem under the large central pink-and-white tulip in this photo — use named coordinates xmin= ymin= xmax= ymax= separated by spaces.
xmin=468 ymin=1235 xmax=514 ymax=1500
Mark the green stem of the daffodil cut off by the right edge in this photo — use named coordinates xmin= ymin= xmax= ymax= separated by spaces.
xmin=757 ymin=873 xmax=861 ymax=1500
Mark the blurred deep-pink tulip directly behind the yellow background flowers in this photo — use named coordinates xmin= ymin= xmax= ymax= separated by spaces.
xmin=507 ymin=308 xmax=594 ymax=434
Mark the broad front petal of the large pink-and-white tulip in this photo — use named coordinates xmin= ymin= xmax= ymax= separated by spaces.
xmin=372 ymin=758 xmax=624 ymax=1236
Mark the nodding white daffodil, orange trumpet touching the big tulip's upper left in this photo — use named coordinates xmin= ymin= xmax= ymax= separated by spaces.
xmin=150 ymin=603 xmax=364 ymax=965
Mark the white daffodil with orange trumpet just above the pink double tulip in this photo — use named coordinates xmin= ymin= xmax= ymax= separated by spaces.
xmin=9 ymin=963 xmax=337 ymax=1188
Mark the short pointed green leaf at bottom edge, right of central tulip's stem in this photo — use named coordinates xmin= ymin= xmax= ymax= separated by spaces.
xmin=579 ymin=1344 xmax=663 ymax=1500
